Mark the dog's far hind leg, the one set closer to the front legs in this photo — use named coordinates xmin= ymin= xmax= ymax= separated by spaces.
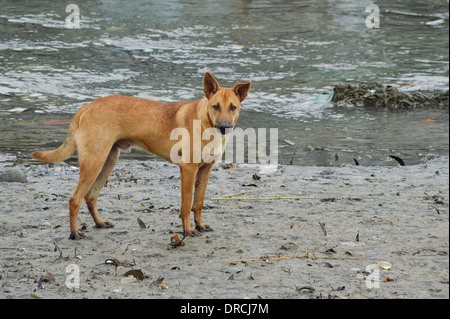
xmin=84 ymin=146 xmax=120 ymax=228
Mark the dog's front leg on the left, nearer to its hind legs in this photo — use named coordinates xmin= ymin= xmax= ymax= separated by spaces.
xmin=180 ymin=163 xmax=201 ymax=236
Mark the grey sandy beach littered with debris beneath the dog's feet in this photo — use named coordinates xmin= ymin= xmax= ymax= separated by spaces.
xmin=0 ymin=157 xmax=449 ymax=299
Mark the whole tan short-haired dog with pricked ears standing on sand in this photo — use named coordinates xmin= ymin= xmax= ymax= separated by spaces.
xmin=31 ymin=72 xmax=250 ymax=239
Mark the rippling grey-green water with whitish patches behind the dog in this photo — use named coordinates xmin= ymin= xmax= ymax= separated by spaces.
xmin=0 ymin=0 xmax=449 ymax=166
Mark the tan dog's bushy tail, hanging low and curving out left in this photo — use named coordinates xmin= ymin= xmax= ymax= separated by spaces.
xmin=31 ymin=114 xmax=79 ymax=163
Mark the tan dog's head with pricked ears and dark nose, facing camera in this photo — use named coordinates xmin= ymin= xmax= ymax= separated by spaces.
xmin=203 ymin=72 xmax=251 ymax=134
